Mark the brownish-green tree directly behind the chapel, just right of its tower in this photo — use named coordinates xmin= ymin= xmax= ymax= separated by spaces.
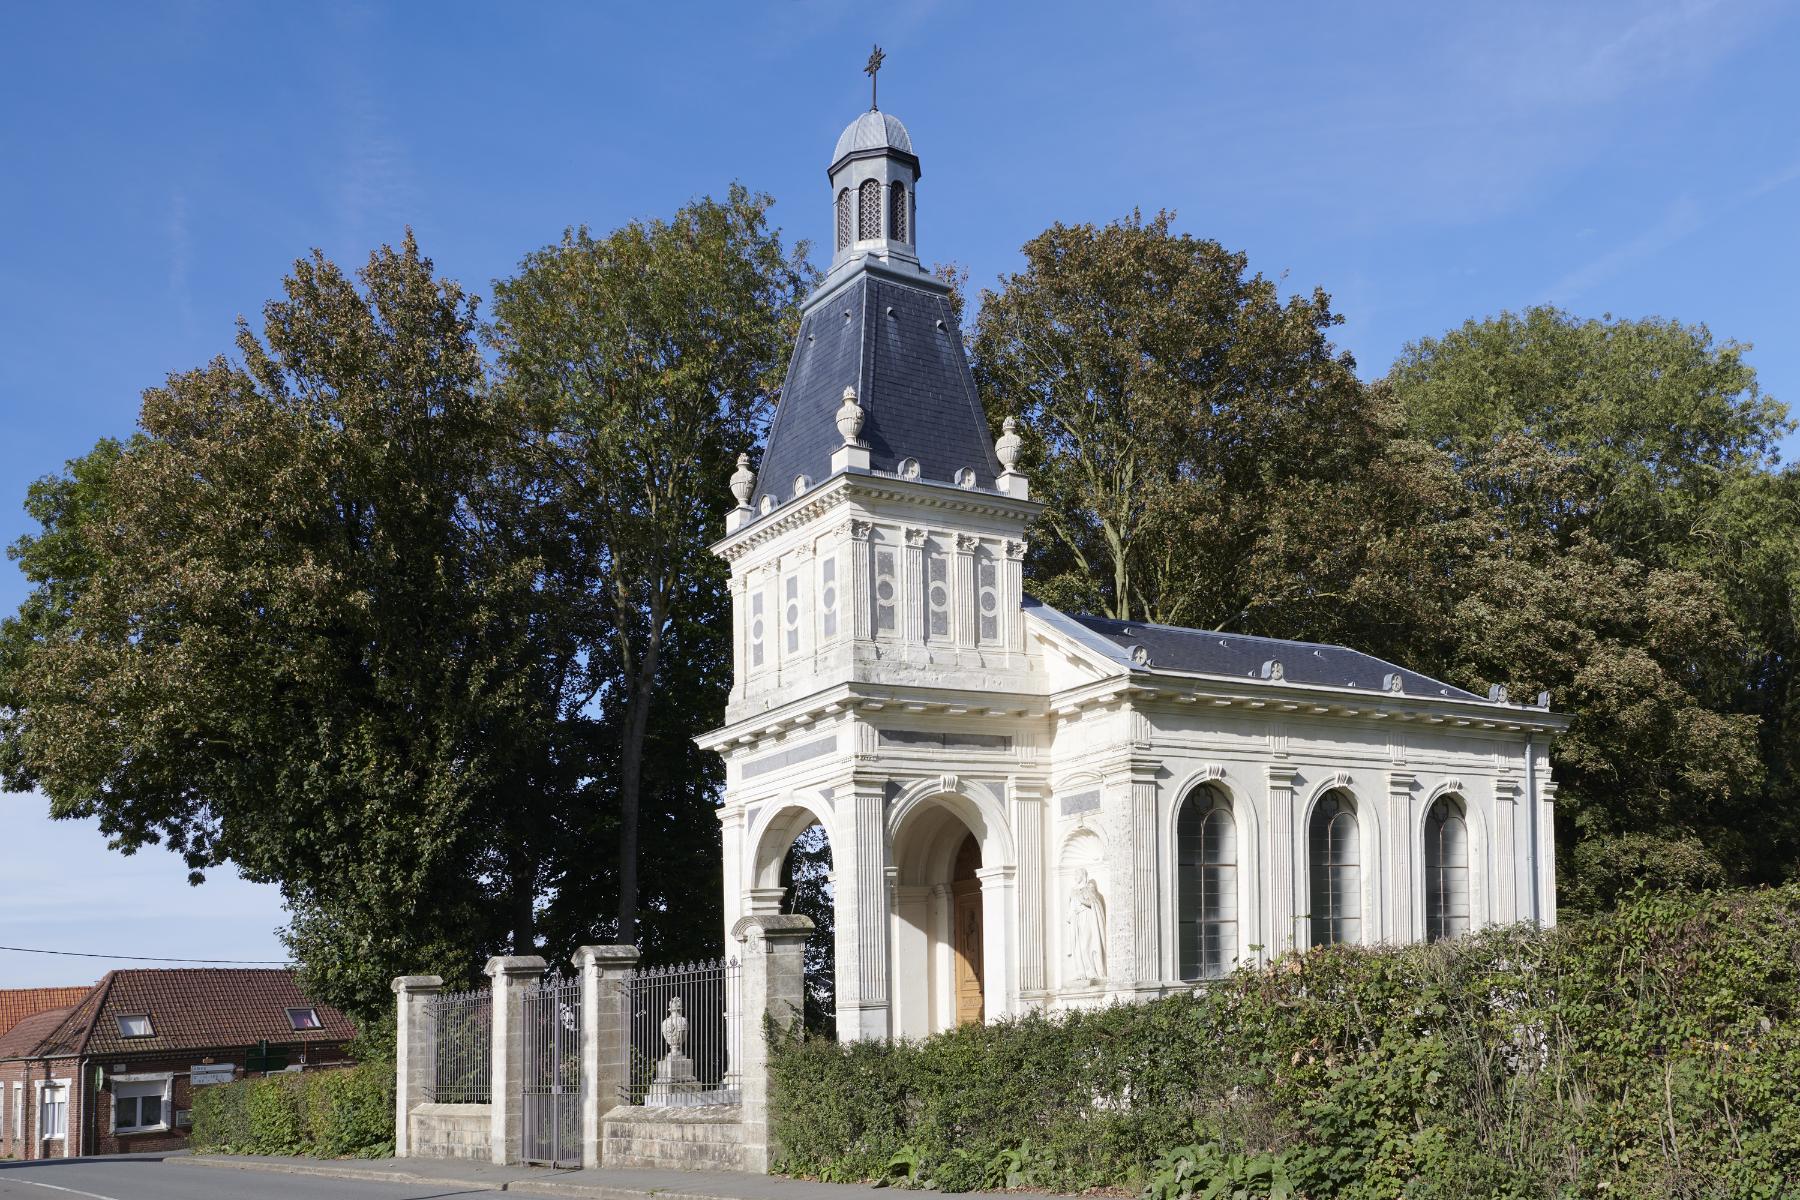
xmin=974 ymin=212 xmax=1386 ymax=628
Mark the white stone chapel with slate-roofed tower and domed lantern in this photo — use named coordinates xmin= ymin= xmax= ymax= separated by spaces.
xmin=700 ymin=98 xmax=1566 ymax=1038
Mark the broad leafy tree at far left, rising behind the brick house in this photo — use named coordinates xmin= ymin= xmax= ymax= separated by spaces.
xmin=0 ymin=234 xmax=572 ymax=1013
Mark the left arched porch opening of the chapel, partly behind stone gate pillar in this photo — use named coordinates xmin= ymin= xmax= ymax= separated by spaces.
xmin=745 ymin=804 xmax=839 ymax=1036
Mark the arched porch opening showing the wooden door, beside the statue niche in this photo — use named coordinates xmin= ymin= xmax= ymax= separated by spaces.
xmin=891 ymin=793 xmax=1012 ymax=1038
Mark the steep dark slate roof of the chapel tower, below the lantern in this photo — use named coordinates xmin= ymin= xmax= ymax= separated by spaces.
xmin=752 ymin=266 xmax=1001 ymax=509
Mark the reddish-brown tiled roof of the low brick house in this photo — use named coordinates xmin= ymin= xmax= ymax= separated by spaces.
xmin=5 ymin=968 xmax=356 ymax=1058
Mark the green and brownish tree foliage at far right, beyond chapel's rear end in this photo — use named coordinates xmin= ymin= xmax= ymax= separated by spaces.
xmin=1386 ymin=308 xmax=1800 ymax=907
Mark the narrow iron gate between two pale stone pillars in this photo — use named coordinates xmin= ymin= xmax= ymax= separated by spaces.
xmin=520 ymin=975 xmax=581 ymax=1168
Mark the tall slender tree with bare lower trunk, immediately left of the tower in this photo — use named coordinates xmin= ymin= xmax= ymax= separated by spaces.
xmin=493 ymin=187 xmax=812 ymax=941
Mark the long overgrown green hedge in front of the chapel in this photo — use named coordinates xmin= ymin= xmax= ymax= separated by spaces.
xmin=770 ymin=885 xmax=1800 ymax=1200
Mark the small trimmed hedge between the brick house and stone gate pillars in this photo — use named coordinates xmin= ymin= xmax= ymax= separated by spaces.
xmin=191 ymin=1061 xmax=394 ymax=1159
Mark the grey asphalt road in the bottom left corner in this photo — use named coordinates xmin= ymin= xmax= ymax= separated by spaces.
xmin=0 ymin=1155 xmax=495 ymax=1200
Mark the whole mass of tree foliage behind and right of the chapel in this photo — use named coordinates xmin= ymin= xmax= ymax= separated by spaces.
xmin=974 ymin=214 xmax=1800 ymax=907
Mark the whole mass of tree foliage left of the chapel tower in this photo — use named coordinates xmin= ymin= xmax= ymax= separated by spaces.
xmin=0 ymin=189 xmax=805 ymax=1015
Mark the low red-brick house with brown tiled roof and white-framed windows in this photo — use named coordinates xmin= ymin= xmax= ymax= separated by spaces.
xmin=0 ymin=968 xmax=355 ymax=1159
